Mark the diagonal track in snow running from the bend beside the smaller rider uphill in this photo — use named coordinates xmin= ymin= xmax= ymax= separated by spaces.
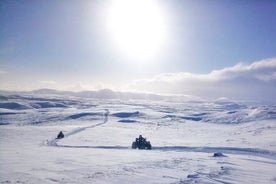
xmin=46 ymin=109 xmax=109 ymax=147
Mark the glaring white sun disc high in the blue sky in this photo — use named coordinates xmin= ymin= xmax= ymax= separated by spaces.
xmin=107 ymin=0 xmax=166 ymax=59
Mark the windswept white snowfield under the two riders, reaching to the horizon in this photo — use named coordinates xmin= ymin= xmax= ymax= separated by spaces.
xmin=0 ymin=93 xmax=276 ymax=184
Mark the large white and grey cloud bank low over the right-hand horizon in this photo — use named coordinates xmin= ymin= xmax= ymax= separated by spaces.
xmin=130 ymin=58 xmax=276 ymax=103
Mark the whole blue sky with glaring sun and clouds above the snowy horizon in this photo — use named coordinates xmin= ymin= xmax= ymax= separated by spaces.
xmin=0 ymin=0 xmax=276 ymax=104
